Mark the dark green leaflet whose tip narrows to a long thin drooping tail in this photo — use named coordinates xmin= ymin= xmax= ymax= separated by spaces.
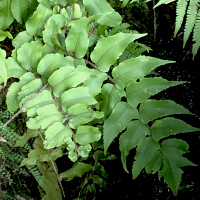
xmin=119 ymin=120 xmax=150 ymax=173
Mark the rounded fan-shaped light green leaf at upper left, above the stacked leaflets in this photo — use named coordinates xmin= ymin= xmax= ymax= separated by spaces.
xmin=17 ymin=41 xmax=43 ymax=72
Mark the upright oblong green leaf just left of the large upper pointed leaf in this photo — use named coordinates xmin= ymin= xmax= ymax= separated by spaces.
xmin=65 ymin=17 xmax=90 ymax=58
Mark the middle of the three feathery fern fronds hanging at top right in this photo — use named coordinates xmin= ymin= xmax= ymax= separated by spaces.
xmin=183 ymin=0 xmax=199 ymax=48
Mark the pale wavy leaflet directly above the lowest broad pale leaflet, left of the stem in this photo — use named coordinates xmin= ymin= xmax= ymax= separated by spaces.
xmin=26 ymin=104 xmax=65 ymax=129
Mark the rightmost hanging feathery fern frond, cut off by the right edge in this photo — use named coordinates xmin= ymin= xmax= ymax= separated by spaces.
xmin=192 ymin=9 xmax=200 ymax=60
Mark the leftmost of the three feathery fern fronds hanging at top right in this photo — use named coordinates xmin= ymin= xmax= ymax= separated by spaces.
xmin=174 ymin=0 xmax=188 ymax=37
